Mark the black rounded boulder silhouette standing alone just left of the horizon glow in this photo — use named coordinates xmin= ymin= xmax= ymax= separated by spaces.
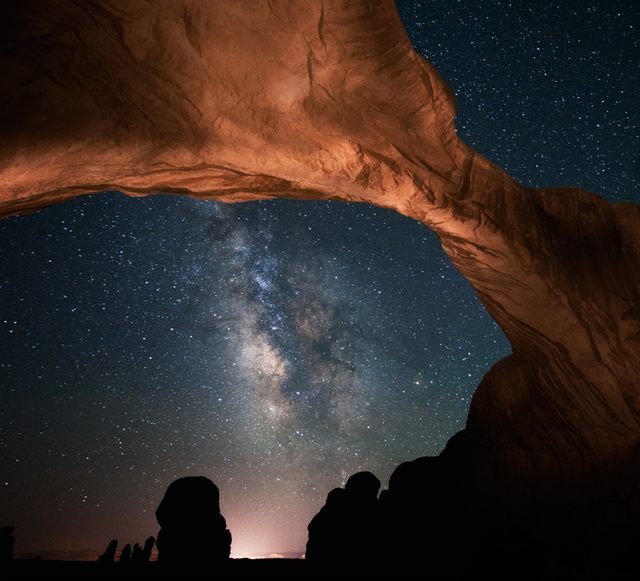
xmin=156 ymin=476 xmax=231 ymax=566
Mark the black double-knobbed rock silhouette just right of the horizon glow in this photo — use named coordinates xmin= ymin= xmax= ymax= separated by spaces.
xmin=305 ymin=472 xmax=384 ymax=568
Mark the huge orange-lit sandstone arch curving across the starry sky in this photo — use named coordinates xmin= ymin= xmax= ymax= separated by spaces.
xmin=0 ymin=0 xmax=640 ymax=576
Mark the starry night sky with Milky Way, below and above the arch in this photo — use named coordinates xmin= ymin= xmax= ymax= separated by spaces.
xmin=0 ymin=0 xmax=640 ymax=557
